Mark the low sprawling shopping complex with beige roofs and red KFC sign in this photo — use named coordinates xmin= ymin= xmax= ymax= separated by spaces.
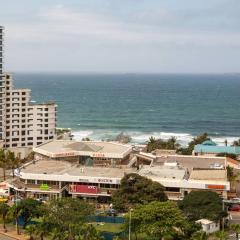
xmin=2 ymin=140 xmax=234 ymax=202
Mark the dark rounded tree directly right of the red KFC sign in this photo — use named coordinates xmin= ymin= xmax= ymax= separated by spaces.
xmin=112 ymin=173 xmax=167 ymax=211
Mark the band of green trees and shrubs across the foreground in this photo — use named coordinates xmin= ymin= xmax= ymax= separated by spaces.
xmin=0 ymin=190 xmax=232 ymax=240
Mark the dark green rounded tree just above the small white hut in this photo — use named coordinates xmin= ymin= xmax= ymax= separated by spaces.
xmin=179 ymin=191 xmax=226 ymax=221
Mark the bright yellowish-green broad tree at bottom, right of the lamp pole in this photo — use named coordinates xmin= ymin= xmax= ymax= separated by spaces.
xmin=126 ymin=201 xmax=198 ymax=240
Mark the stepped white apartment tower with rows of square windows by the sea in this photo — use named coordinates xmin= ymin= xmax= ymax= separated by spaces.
xmin=0 ymin=28 xmax=57 ymax=148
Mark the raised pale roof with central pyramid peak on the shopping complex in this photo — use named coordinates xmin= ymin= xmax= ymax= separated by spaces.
xmin=33 ymin=140 xmax=132 ymax=157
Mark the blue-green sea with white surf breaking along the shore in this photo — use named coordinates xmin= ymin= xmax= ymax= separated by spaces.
xmin=14 ymin=73 xmax=240 ymax=144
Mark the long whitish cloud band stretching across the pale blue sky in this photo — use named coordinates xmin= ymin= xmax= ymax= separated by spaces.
xmin=4 ymin=5 xmax=240 ymax=46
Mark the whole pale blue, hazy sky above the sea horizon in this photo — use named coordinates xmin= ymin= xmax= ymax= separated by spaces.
xmin=0 ymin=0 xmax=240 ymax=73
